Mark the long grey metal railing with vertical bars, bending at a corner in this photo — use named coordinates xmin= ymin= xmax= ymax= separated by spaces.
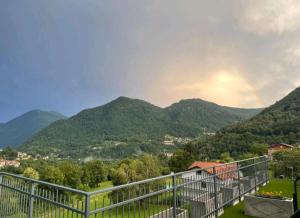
xmin=0 ymin=156 xmax=268 ymax=218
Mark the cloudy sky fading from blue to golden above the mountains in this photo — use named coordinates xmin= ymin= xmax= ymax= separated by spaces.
xmin=0 ymin=0 xmax=300 ymax=122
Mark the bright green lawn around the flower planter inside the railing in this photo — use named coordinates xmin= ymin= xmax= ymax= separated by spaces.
xmin=220 ymin=179 xmax=294 ymax=218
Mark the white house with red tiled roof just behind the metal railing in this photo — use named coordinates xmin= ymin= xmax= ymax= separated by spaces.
xmin=182 ymin=161 xmax=238 ymax=218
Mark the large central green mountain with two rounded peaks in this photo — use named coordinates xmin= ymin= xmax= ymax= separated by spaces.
xmin=22 ymin=97 xmax=260 ymax=158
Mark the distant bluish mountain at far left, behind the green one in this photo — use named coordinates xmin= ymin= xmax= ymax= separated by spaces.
xmin=0 ymin=110 xmax=65 ymax=147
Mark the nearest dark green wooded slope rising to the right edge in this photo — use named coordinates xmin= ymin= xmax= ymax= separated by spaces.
xmin=188 ymin=88 xmax=300 ymax=158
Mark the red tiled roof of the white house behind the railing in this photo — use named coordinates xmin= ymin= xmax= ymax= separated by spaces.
xmin=189 ymin=161 xmax=238 ymax=180
